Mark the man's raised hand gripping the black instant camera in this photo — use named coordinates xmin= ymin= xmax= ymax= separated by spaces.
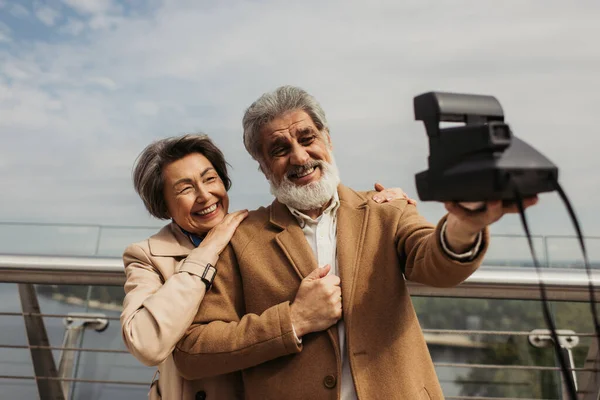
xmin=444 ymin=196 xmax=538 ymax=253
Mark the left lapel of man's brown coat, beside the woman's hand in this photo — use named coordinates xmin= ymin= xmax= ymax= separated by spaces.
xmin=271 ymin=200 xmax=317 ymax=279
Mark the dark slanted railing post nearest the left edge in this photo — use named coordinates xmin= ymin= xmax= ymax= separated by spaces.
xmin=19 ymin=283 xmax=65 ymax=400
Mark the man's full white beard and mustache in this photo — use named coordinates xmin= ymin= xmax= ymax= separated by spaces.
xmin=269 ymin=154 xmax=340 ymax=211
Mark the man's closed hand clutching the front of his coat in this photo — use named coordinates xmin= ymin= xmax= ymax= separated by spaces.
xmin=290 ymin=265 xmax=342 ymax=338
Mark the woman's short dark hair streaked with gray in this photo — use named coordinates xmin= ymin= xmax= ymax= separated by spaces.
xmin=133 ymin=134 xmax=231 ymax=219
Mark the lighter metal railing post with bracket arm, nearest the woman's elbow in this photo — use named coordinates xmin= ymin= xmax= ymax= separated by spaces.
xmin=58 ymin=313 xmax=108 ymax=399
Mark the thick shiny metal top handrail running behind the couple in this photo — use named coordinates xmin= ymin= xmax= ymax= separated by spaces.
xmin=0 ymin=255 xmax=600 ymax=301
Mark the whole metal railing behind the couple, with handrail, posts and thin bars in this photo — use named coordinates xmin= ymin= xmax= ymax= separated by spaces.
xmin=0 ymin=254 xmax=600 ymax=400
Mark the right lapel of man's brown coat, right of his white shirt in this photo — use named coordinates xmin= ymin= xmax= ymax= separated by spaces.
xmin=337 ymin=185 xmax=368 ymax=319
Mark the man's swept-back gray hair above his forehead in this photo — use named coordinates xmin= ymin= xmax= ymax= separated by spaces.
xmin=242 ymin=86 xmax=329 ymax=163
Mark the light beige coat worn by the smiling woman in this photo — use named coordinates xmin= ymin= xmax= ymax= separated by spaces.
xmin=121 ymin=223 xmax=243 ymax=400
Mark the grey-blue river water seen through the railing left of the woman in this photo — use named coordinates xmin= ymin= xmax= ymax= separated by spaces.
xmin=0 ymin=283 xmax=154 ymax=400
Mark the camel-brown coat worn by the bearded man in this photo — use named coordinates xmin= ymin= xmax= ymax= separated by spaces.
xmin=174 ymin=186 xmax=489 ymax=400
